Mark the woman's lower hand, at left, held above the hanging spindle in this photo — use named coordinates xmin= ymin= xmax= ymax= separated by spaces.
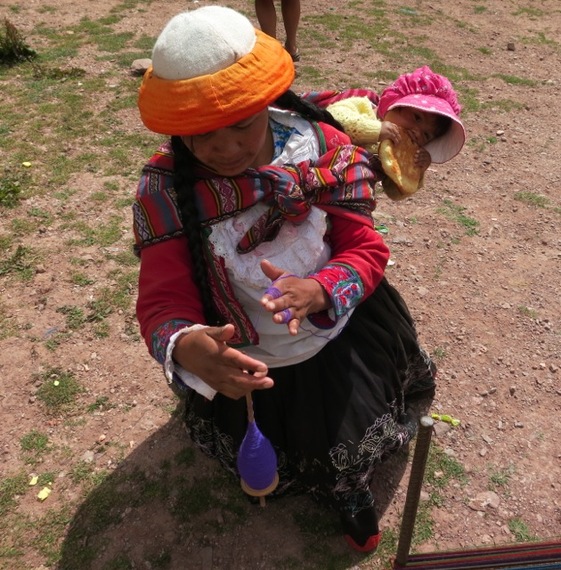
xmin=173 ymin=324 xmax=274 ymax=400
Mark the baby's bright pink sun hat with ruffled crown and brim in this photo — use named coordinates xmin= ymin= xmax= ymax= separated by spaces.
xmin=377 ymin=65 xmax=466 ymax=163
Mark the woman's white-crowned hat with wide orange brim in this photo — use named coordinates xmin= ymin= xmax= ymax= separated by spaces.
xmin=138 ymin=6 xmax=294 ymax=135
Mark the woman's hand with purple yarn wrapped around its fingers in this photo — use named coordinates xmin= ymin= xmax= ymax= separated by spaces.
xmin=261 ymin=259 xmax=331 ymax=335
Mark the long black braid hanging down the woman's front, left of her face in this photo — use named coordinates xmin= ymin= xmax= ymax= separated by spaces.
xmin=171 ymin=137 xmax=222 ymax=325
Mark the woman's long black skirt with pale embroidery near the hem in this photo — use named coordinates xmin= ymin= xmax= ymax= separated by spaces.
xmin=182 ymin=279 xmax=436 ymax=515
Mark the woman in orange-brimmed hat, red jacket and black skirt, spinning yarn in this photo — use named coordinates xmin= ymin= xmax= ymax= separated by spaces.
xmin=134 ymin=6 xmax=434 ymax=551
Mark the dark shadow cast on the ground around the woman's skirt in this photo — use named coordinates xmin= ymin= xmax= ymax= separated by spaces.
xmin=57 ymin=402 xmax=407 ymax=570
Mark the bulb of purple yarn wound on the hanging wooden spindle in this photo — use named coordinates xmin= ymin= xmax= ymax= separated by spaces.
xmin=237 ymin=422 xmax=277 ymax=491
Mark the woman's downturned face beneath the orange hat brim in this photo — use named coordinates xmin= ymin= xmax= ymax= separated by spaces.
xmin=181 ymin=109 xmax=273 ymax=176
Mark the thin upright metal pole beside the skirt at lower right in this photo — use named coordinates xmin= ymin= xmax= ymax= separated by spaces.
xmin=395 ymin=416 xmax=434 ymax=566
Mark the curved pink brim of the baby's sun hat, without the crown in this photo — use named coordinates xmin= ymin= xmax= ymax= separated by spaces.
xmin=384 ymin=93 xmax=466 ymax=164
